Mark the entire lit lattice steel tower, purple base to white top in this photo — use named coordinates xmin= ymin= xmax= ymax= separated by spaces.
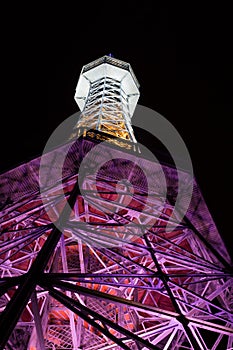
xmin=0 ymin=56 xmax=233 ymax=350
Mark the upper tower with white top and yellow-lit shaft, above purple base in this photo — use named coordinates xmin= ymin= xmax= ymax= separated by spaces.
xmin=72 ymin=56 xmax=139 ymax=144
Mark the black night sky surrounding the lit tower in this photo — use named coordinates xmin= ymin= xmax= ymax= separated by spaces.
xmin=0 ymin=2 xmax=232 ymax=258
